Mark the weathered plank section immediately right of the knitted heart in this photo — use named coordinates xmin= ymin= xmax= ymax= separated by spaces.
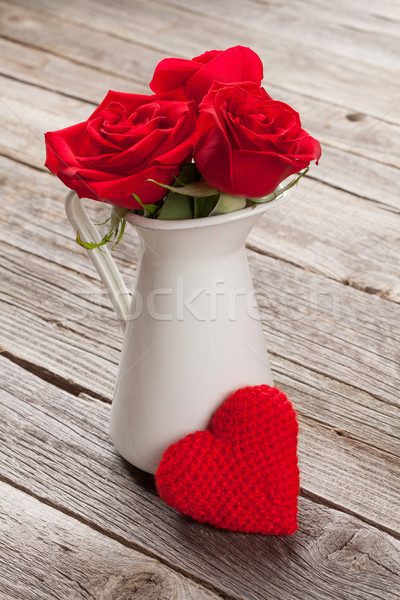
xmin=300 ymin=418 xmax=400 ymax=534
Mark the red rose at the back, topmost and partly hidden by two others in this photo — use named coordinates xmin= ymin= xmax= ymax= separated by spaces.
xmin=150 ymin=46 xmax=263 ymax=104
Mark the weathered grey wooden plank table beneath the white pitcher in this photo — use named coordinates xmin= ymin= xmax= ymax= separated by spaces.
xmin=0 ymin=0 xmax=400 ymax=600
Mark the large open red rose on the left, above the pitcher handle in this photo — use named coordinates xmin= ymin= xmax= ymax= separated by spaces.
xmin=45 ymin=91 xmax=196 ymax=208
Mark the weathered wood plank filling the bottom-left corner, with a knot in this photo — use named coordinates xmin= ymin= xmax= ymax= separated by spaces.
xmin=0 ymin=482 xmax=219 ymax=600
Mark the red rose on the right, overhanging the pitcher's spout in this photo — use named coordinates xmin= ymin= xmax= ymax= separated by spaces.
xmin=194 ymin=83 xmax=321 ymax=198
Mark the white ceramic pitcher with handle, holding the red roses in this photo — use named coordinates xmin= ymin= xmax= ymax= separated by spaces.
xmin=66 ymin=192 xmax=287 ymax=473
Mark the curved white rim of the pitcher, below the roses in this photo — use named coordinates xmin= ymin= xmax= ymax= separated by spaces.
xmin=124 ymin=185 xmax=290 ymax=231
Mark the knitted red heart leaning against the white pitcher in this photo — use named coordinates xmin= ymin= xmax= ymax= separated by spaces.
xmin=156 ymin=385 xmax=299 ymax=535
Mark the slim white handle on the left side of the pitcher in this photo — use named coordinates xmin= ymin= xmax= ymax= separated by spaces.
xmin=65 ymin=191 xmax=131 ymax=330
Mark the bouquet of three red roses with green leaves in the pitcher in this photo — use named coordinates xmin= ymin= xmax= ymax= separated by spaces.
xmin=45 ymin=46 xmax=321 ymax=248
